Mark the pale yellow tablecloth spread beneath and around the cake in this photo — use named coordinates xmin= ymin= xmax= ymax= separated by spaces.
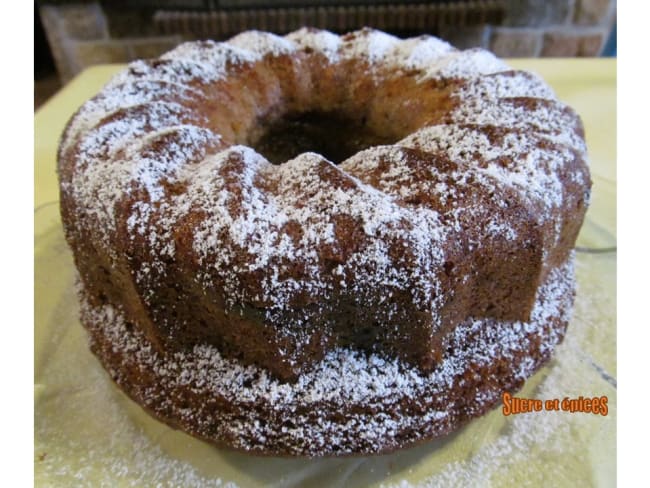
xmin=34 ymin=59 xmax=616 ymax=486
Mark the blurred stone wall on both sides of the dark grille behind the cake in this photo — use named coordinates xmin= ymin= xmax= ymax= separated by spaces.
xmin=36 ymin=0 xmax=616 ymax=82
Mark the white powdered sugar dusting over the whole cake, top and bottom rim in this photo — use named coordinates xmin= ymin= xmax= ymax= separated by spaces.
xmin=60 ymin=29 xmax=589 ymax=458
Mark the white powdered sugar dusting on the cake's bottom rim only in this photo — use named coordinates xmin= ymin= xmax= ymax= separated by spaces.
xmin=82 ymin=261 xmax=573 ymax=455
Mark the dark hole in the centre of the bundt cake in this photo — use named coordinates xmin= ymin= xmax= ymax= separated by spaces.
xmin=253 ymin=112 xmax=395 ymax=164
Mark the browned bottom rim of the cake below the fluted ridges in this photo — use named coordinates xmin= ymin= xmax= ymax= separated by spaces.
xmin=81 ymin=262 xmax=574 ymax=457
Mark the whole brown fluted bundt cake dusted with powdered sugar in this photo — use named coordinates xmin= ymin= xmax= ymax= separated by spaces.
xmin=58 ymin=28 xmax=591 ymax=456
